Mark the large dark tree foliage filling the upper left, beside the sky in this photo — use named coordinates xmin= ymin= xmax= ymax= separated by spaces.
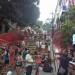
xmin=0 ymin=0 xmax=40 ymax=25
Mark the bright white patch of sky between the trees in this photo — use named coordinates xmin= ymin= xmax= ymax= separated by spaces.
xmin=39 ymin=0 xmax=58 ymax=22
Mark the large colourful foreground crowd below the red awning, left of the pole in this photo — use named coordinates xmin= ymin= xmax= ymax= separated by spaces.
xmin=0 ymin=43 xmax=50 ymax=75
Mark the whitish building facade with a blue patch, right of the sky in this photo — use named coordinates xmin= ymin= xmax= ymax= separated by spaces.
xmin=54 ymin=0 xmax=70 ymax=28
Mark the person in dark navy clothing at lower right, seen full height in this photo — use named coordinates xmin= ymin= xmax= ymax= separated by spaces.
xmin=57 ymin=50 xmax=69 ymax=75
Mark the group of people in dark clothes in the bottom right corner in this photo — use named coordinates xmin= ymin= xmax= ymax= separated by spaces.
xmin=57 ymin=49 xmax=75 ymax=75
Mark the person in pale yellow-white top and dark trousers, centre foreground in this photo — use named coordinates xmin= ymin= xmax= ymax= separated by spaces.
xmin=25 ymin=51 xmax=33 ymax=75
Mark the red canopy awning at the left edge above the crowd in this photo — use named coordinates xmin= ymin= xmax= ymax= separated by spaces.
xmin=0 ymin=32 xmax=21 ymax=43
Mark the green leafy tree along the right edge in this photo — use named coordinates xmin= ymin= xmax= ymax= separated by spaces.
xmin=60 ymin=6 xmax=75 ymax=48
